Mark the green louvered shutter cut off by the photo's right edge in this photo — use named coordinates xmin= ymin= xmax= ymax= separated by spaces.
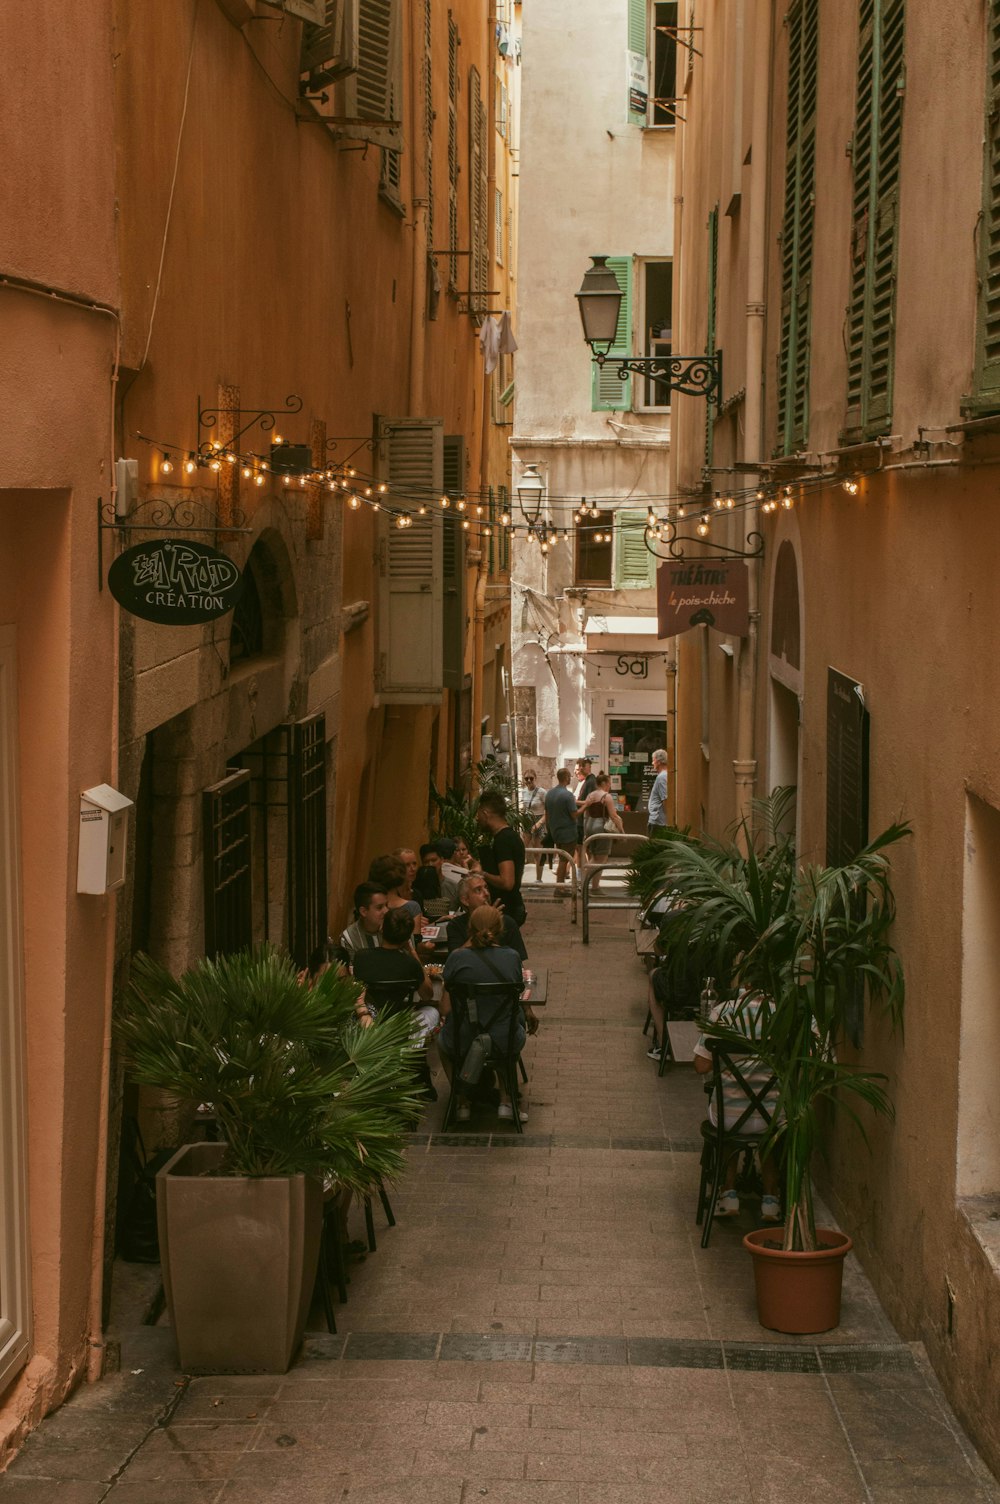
xmin=962 ymin=0 xmax=1000 ymax=412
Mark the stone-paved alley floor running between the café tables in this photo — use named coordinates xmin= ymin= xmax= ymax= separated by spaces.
xmin=0 ymin=904 xmax=1000 ymax=1504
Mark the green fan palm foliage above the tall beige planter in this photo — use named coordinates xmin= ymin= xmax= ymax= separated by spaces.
xmin=116 ymin=946 xmax=423 ymax=1191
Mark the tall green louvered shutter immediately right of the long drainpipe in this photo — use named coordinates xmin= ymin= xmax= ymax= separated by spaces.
xmin=777 ymin=0 xmax=820 ymax=454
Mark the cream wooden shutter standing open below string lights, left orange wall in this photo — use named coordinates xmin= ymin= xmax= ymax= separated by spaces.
xmin=377 ymin=418 xmax=448 ymax=704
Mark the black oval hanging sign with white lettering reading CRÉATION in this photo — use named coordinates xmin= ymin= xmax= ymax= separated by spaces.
xmin=108 ymin=538 xmax=244 ymax=627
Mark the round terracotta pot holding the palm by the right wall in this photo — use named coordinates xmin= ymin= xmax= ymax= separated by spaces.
xmin=743 ymin=1227 xmax=853 ymax=1333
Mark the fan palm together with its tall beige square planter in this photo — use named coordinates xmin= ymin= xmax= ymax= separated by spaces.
xmin=116 ymin=946 xmax=423 ymax=1372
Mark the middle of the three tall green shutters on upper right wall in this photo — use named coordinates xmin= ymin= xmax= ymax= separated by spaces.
xmin=845 ymin=0 xmax=905 ymax=441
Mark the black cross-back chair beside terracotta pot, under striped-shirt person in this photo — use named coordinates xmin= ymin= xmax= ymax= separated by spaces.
xmin=695 ymin=1038 xmax=777 ymax=1248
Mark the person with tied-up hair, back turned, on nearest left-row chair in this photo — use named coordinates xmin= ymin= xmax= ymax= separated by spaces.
xmin=438 ymin=904 xmax=538 ymax=1122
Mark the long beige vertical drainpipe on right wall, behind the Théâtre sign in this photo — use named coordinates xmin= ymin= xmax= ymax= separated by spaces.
xmin=732 ymin=5 xmax=773 ymax=826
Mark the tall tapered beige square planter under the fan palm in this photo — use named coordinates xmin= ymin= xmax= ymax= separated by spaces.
xmin=156 ymin=1143 xmax=323 ymax=1373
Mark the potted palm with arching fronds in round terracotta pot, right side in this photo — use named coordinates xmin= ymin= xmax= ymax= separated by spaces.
xmin=631 ymin=805 xmax=908 ymax=1333
